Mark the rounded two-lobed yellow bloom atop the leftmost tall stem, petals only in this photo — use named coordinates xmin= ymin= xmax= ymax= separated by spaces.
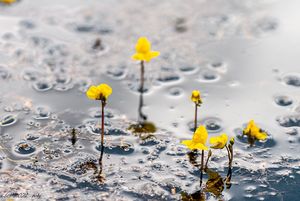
xmin=86 ymin=84 xmax=112 ymax=101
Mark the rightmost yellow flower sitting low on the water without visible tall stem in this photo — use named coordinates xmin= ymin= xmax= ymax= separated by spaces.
xmin=243 ymin=119 xmax=268 ymax=146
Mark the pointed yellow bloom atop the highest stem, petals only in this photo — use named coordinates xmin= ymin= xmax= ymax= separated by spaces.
xmin=132 ymin=37 xmax=160 ymax=62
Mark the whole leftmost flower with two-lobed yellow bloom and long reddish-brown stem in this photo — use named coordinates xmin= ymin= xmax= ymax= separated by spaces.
xmin=86 ymin=84 xmax=112 ymax=178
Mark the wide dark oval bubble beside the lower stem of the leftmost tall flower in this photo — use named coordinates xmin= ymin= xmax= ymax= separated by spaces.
xmin=96 ymin=139 xmax=134 ymax=155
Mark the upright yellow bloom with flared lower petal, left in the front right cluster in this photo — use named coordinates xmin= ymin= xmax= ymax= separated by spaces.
xmin=181 ymin=125 xmax=208 ymax=150
